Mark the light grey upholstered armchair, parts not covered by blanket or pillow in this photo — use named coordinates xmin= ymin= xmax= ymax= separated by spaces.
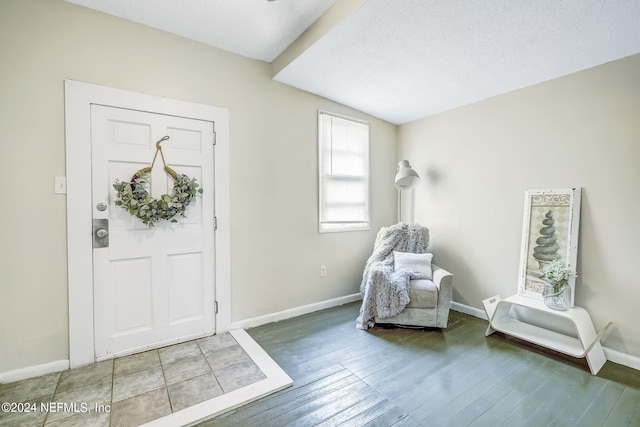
xmin=375 ymin=227 xmax=453 ymax=328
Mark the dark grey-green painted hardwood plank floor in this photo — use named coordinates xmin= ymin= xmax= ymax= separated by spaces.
xmin=201 ymin=303 xmax=640 ymax=427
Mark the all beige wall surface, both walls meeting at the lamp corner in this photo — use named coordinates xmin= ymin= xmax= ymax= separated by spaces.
xmin=0 ymin=0 xmax=640 ymax=373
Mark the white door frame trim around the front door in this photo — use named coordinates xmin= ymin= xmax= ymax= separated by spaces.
xmin=64 ymin=80 xmax=231 ymax=368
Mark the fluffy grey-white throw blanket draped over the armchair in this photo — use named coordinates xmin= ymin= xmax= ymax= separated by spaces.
xmin=356 ymin=223 xmax=426 ymax=329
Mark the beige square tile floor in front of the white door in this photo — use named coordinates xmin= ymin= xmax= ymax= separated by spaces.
xmin=0 ymin=333 xmax=265 ymax=427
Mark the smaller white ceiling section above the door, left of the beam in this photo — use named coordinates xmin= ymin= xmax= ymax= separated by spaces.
xmin=67 ymin=0 xmax=336 ymax=62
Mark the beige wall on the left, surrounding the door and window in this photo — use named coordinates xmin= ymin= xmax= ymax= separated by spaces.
xmin=0 ymin=0 xmax=397 ymax=373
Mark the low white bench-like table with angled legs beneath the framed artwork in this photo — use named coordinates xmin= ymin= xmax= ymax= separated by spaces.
xmin=482 ymin=295 xmax=612 ymax=375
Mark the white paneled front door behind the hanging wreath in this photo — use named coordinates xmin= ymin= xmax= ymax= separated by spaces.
xmin=91 ymin=105 xmax=215 ymax=360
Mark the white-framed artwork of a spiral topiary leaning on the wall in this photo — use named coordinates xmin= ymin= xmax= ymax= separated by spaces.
xmin=518 ymin=187 xmax=581 ymax=307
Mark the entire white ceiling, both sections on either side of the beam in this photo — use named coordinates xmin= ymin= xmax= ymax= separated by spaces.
xmin=68 ymin=0 xmax=640 ymax=124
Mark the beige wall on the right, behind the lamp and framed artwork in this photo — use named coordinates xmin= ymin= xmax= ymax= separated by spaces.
xmin=398 ymin=55 xmax=640 ymax=357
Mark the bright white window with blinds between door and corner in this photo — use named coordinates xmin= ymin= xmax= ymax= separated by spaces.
xmin=318 ymin=111 xmax=369 ymax=233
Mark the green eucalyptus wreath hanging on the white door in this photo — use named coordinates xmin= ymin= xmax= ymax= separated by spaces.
xmin=113 ymin=172 xmax=202 ymax=228
